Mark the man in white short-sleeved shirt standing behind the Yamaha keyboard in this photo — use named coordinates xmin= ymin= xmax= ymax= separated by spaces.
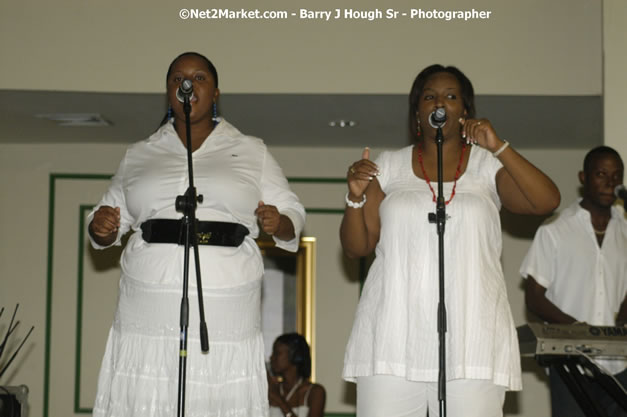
xmin=520 ymin=146 xmax=627 ymax=417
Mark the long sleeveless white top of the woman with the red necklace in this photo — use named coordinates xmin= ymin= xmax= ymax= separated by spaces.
xmin=343 ymin=146 xmax=521 ymax=390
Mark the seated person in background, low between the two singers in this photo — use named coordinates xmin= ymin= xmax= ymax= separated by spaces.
xmin=268 ymin=333 xmax=326 ymax=417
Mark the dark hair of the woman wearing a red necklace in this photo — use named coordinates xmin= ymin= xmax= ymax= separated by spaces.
xmin=409 ymin=64 xmax=475 ymax=138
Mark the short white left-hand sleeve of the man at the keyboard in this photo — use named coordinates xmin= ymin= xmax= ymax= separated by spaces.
xmin=520 ymin=226 xmax=557 ymax=288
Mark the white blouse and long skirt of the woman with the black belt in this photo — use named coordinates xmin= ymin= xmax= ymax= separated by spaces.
xmin=88 ymin=121 xmax=305 ymax=417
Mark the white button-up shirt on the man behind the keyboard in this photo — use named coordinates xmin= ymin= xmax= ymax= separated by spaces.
xmin=520 ymin=200 xmax=627 ymax=373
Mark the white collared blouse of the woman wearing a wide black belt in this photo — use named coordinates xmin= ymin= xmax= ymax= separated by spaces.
xmin=88 ymin=120 xmax=305 ymax=288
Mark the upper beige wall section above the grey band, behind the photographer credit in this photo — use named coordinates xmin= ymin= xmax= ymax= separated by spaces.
xmin=0 ymin=0 xmax=604 ymax=95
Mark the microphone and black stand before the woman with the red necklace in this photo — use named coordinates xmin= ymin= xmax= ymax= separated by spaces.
xmin=428 ymin=125 xmax=446 ymax=417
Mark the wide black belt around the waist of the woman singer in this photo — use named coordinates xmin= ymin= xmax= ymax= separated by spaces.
xmin=141 ymin=219 xmax=249 ymax=246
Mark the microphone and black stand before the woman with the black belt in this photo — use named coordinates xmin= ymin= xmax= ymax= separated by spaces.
xmin=175 ymin=94 xmax=209 ymax=417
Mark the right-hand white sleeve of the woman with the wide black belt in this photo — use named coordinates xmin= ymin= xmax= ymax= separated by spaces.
xmin=261 ymin=148 xmax=305 ymax=252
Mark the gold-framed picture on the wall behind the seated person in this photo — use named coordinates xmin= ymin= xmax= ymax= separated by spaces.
xmin=257 ymin=237 xmax=316 ymax=381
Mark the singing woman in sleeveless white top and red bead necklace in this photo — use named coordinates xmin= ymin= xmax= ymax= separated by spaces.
xmin=340 ymin=65 xmax=560 ymax=417
